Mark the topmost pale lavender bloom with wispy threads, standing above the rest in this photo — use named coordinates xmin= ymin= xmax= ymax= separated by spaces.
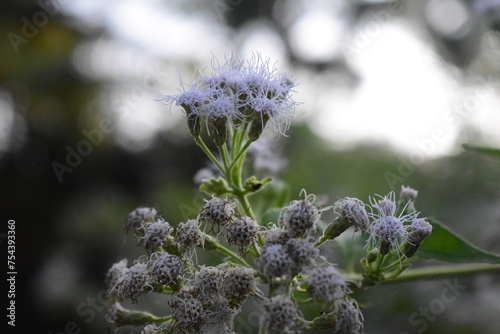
xmin=164 ymin=54 xmax=297 ymax=142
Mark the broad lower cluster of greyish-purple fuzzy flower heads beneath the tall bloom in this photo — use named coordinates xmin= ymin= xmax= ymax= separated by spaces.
xmin=105 ymin=183 xmax=432 ymax=334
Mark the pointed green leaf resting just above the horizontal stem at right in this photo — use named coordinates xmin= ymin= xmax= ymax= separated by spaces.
xmin=417 ymin=219 xmax=500 ymax=263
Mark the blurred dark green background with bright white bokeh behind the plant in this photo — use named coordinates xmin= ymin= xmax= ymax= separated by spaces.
xmin=0 ymin=0 xmax=500 ymax=334
